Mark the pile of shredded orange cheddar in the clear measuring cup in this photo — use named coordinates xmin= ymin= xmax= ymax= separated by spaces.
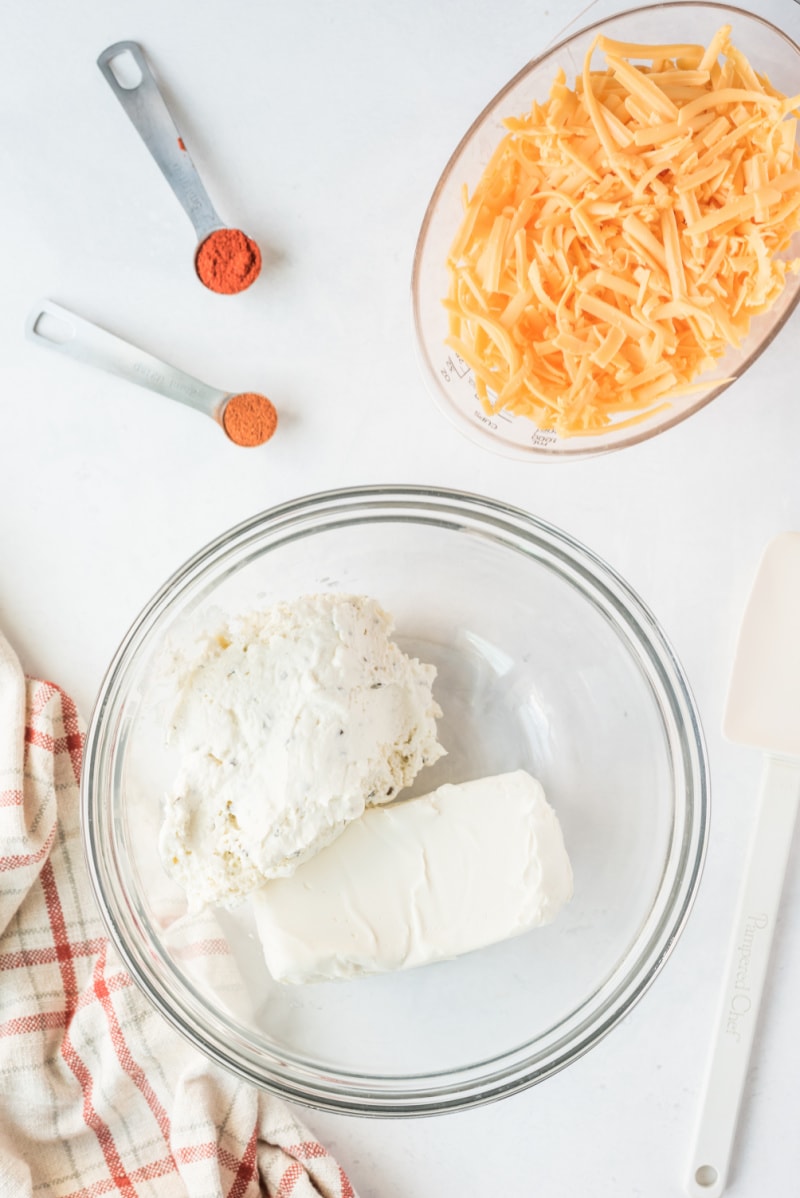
xmin=444 ymin=25 xmax=800 ymax=436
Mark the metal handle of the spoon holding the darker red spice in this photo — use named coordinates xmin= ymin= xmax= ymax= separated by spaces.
xmin=97 ymin=42 xmax=224 ymax=242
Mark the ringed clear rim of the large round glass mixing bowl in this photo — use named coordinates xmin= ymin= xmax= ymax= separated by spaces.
xmin=81 ymin=485 xmax=709 ymax=1118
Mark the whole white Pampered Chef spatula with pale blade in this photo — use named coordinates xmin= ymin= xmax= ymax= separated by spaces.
xmin=686 ymin=532 xmax=800 ymax=1198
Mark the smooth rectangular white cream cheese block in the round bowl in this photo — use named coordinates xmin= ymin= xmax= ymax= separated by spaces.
xmin=250 ymin=770 xmax=572 ymax=982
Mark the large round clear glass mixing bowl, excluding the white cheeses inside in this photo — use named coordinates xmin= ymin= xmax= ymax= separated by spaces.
xmin=81 ymin=486 xmax=708 ymax=1115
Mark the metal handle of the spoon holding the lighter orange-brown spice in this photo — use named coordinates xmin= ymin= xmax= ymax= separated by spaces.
xmin=25 ymin=300 xmax=229 ymax=419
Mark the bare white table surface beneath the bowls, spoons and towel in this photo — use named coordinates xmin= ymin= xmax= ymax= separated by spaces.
xmin=0 ymin=0 xmax=800 ymax=1198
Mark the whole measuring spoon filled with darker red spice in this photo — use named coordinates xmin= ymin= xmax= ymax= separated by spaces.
xmin=97 ymin=42 xmax=261 ymax=295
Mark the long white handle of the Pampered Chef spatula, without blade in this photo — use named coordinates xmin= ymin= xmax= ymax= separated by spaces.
xmin=686 ymin=756 xmax=800 ymax=1198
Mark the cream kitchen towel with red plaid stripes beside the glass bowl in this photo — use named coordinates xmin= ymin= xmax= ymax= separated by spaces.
xmin=0 ymin=635 xmax=356 ymax=1198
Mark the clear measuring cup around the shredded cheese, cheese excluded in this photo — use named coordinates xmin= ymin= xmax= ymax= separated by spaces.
xmin=412 ymin=0 xmax=800 ymax=461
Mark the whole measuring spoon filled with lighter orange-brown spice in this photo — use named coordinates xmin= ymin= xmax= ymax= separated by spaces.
xmin=25 ymin=300 xmax=278 ymax=446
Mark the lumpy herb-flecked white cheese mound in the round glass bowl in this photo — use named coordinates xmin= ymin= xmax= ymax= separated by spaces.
xmin=159 ymin=594 xmax=444 ymax=910
